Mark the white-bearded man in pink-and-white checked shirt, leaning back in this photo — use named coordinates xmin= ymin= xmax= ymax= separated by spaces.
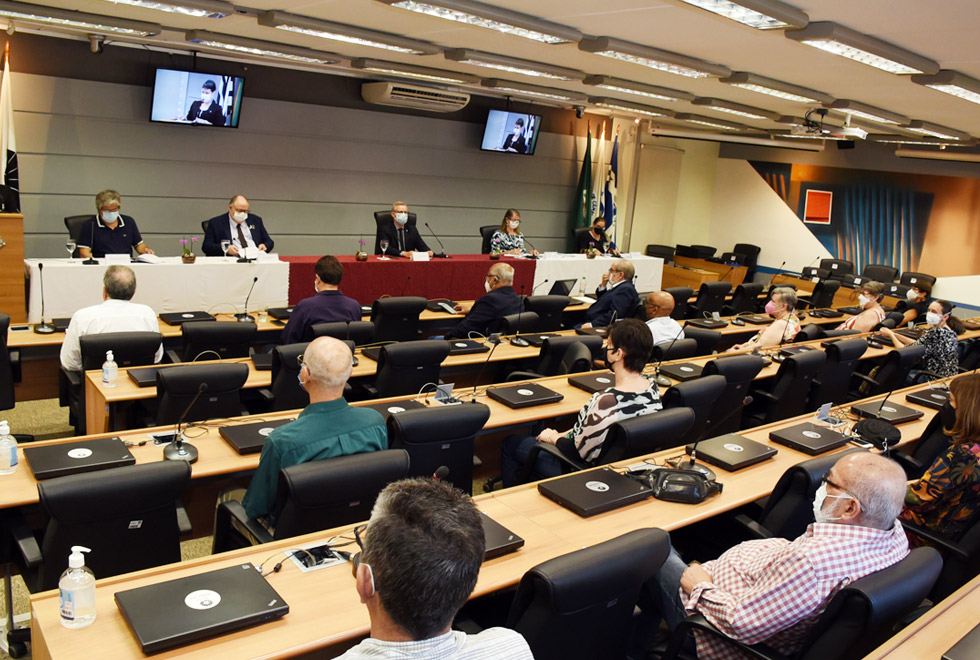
xmin=641 ymin=453 xmax=909 ymax=660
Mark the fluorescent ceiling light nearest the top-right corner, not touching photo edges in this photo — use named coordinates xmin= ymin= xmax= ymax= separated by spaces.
xmin=784 ymin=21 xmax=939 ymax=74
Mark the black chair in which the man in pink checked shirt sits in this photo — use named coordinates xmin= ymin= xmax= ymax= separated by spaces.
xmin=661 ymin=548 xmax=943 ymax=660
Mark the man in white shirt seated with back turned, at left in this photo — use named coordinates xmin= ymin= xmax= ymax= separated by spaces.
xmin=61 ymin=266 xmax=163 ymax=371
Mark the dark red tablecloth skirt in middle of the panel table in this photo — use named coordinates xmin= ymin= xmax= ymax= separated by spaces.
xmin=280 ymin=254 xmax=547 ymax=305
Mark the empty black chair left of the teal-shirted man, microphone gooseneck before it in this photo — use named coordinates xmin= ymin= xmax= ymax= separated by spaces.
xmin=153 ymin=363 xmax=248 ymax=426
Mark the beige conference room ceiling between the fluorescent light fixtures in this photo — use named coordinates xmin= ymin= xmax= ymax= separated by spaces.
xmin=7 ymin=0 xmax=980 ymax=142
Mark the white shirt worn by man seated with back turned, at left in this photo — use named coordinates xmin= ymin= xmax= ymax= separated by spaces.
xmin=61 ymin=298 xmax=163 ymax=371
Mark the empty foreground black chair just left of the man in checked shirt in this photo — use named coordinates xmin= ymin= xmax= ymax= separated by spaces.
xmin=507 ymin=529 xmax=670 ymax=660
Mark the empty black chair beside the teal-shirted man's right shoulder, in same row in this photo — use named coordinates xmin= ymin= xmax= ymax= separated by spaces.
xmin=388 ymin=403 xmax=490 ymax=495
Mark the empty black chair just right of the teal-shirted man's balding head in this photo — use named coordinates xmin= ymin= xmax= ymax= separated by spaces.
xmin=369 ymin=339 xmax=449 ymax=398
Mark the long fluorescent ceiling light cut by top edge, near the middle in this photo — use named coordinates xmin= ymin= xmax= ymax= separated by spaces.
xmin=378 ymin=0 xmax=582 ymax=44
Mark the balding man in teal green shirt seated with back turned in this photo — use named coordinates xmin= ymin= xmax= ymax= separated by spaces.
xmin=242 ymin=337 xmax=388 ymax=526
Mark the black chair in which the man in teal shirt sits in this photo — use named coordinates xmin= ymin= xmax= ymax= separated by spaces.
xmin=211 ymin=449 xmax=410 ymax=554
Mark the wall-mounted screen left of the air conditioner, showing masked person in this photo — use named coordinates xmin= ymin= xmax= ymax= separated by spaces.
xmin=150 ymin=69 xmax=245 ymax=128
